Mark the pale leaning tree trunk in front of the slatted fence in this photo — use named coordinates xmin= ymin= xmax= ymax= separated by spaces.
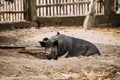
xmin=83 ymin=0 xmax=95 ymax=30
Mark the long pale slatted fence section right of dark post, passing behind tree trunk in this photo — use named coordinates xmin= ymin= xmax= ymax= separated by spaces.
xmin=36 ymin=0 xmax=103 ymax=17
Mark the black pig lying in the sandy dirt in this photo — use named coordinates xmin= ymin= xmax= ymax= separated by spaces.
xmin=39 ymin=32 xmax=101 ymax=59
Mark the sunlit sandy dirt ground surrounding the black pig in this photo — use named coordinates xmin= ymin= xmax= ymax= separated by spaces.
xmin=0 ymin=26 xmax=120 ymax=80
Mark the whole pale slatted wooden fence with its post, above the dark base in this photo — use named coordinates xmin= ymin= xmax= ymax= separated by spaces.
xmin=0 ymin=0 xmax=104 ymax=23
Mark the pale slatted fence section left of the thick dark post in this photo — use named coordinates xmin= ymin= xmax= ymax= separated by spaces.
xmin=0 ymin=0 xmax=25 ymax=23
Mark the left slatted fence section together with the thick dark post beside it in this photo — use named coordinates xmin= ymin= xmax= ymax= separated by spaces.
xmin=0 ymin=0 xmax=36 ymax=23
